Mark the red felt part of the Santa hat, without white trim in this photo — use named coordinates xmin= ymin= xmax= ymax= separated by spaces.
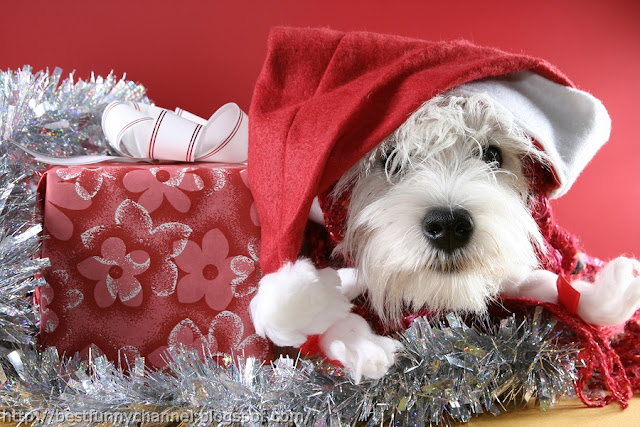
xmin=249 ymin=28 xmax=572 ymax=273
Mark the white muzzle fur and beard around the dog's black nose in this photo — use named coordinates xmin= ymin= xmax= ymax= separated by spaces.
xmin=338 ymin=161 xmax=543 ymax=323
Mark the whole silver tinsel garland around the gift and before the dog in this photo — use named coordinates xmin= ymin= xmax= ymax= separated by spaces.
xmin=0 ymin=67 xmax=576 ymax=426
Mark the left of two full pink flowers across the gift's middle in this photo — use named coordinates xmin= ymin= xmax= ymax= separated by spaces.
xmin=78 ymin=237 xmax=150 ymax=308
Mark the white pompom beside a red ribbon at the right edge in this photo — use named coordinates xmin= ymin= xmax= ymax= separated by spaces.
xmin=572 ymin=257 xmax=640 ymax=326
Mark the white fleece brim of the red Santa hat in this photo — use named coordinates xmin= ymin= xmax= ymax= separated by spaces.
xmin=452 ymin=71 xmax=611 ymax=198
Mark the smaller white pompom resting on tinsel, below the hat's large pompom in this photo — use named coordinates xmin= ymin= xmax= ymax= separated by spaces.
xmin=320 ymin=313 xmax=402 ymax=384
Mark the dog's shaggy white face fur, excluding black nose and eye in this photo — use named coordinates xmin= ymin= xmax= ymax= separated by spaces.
xmin=337 ymin=95 xmax=543 ymax=321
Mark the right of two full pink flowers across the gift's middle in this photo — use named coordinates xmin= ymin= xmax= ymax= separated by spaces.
xmin=176 ymin=228 xmax=255 ymax=311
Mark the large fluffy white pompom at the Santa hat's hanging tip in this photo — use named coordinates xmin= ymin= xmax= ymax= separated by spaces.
xmin=249 ymin=259 xmax=351 ymax=347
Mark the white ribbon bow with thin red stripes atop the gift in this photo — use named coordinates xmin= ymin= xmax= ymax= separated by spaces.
xmin=20 ymin=101 xmax=249 ymax=165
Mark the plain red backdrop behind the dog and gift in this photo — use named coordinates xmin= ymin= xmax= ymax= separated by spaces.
xmin=0 ymin=0 xmax=640 ymax=259
